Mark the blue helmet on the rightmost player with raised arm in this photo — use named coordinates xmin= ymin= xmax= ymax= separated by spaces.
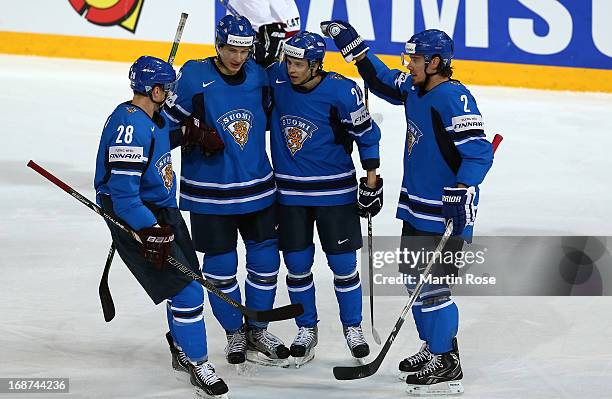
xmin=402 ymin=29 xmax=454 ymax=67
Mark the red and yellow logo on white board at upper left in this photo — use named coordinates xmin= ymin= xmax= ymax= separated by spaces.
xmin=68 ymin=0 xmax=144 ymax=33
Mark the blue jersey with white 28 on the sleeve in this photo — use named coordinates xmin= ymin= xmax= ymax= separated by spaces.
xmin=94 ymin=102 xmax=176 ymax=230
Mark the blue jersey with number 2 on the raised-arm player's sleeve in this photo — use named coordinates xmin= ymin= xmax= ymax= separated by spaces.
xmin=358 ymin=54 xmax=493 ymax=239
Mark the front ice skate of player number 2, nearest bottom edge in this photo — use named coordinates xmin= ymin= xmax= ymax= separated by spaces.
xmin=406 ymin=339 xmax=463 ymax=396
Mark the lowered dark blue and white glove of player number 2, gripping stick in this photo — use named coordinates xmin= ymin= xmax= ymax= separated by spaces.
xmin=442 ymin=187 xmax=476 ymax=236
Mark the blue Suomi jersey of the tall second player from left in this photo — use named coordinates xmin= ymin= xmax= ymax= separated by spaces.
xmin=164 ymin=58 xmax=276 ymax=215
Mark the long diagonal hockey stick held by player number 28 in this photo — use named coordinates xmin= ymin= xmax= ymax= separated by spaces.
xmin=28 ymin=160 xmax=304 ymax=322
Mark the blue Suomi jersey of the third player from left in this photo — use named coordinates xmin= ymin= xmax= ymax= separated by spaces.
xmin=268 ymin=63 xmax=380 ymax=206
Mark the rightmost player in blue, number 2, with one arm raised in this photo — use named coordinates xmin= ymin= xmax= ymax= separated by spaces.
xmin=321 ymin=21 xmax=493 ymax=394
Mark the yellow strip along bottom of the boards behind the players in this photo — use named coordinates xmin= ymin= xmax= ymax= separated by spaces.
xmin=0 ymin=32 xmax=612 ymax=92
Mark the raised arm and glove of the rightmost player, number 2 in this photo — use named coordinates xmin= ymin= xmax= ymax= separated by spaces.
xmin=321 ymin=20 xmax=411 ymax=105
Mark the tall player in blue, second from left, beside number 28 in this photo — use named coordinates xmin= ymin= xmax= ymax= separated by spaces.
xmin=164 ymin=15 xmax=289 ymax=366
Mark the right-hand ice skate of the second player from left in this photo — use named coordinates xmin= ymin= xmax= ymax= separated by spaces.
xmin=247 ymin=327 xmax=289 ymax=367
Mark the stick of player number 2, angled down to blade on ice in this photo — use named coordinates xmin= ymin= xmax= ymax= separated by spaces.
xmin=334 ymin=221 xmax=453 ymax=380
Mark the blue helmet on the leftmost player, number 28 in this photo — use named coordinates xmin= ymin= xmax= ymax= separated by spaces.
xmin=129 ymin=55 xmax=176 ymax=94
